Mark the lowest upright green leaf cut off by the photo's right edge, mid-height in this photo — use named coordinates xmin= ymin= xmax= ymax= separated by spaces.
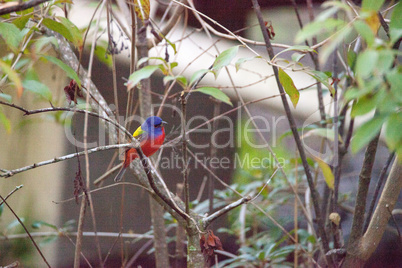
xmin=385 ymin=113 xmax=402 ymax=151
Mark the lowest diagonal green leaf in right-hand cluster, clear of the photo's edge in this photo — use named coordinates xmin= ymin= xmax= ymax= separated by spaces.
xmin=351 ymin=116 xmax=386 ymax=153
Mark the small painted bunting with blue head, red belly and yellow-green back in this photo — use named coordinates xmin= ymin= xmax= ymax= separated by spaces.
xmin=114 ymin=116 xmax=166 ymax=182
